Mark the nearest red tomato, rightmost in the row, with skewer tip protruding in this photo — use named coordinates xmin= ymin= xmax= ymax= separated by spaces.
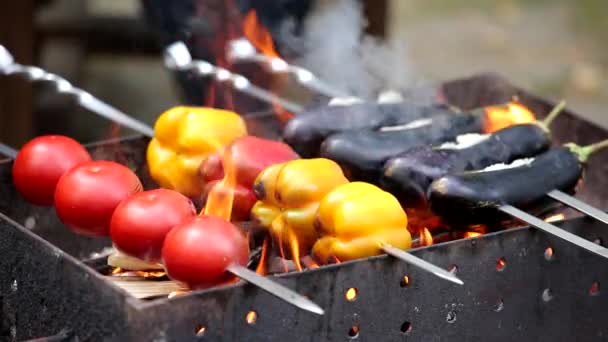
xmin=163 ymin=216 xmax=249 ymax=289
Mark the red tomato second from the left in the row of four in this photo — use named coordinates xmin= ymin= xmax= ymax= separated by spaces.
xmin=55 ymin=160 xmax=142 ymax=236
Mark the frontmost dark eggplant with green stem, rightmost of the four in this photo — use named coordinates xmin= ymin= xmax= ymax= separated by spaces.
xmin=428 ymin=147 xmax=583 ymax=224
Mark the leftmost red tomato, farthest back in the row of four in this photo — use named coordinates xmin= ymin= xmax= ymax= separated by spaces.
xmin=13 ymin=135 xmax=91 ymax=206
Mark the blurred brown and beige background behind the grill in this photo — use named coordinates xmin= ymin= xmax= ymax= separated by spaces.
xmin=0 ymin=0 xmax=608 ymax=148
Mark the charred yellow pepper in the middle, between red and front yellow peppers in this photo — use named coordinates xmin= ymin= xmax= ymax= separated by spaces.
xmin=251 ymin=158 xmax=348 ymax=257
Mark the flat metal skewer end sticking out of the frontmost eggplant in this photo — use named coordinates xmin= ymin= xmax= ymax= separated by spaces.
xmin=498 ymin=204 xmax=608 ymax=258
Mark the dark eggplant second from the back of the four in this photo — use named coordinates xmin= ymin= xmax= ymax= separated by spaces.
xmin=321 ymin=113 xmax=482 ymax=184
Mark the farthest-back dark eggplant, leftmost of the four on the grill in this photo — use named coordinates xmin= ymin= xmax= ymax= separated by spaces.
xmin=283 ymin=102 xmax=453 ymax=158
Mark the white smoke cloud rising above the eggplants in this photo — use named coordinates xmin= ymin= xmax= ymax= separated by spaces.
xmin=282 ymin=0 xmax=413 ymax=98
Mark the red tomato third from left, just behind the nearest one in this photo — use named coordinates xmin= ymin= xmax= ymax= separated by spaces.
xmin=110 ymin=189 xmax=196 ymax=262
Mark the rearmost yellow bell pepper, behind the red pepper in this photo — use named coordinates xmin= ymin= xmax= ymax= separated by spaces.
xmin=147 ymin=107 xmax=247 ymax=197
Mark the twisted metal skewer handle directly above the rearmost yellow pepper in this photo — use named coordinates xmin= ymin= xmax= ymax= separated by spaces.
xmin=164 ymin=42 xmax=303 ymax=112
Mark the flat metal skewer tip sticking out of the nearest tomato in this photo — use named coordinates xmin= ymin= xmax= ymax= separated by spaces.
xmin=227 ymin=264 xmax=325 ymax=315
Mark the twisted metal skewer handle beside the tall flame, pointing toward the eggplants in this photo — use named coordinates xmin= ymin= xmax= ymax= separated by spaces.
xmin=227 ymin=37 xmax=347 ymax=97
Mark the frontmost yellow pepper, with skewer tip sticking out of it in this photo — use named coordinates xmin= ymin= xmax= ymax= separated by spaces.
xmin=312 ymin=182 xmax=412 ymax=263
